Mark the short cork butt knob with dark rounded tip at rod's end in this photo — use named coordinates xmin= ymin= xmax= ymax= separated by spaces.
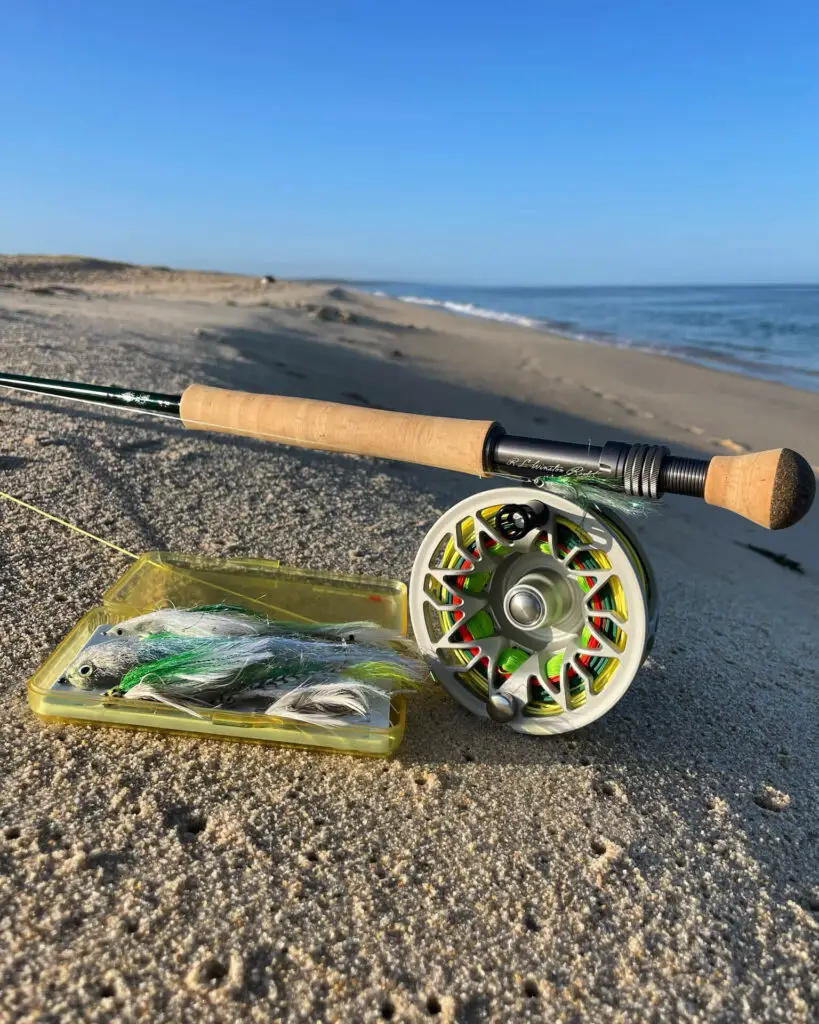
xmin=704 ymin=449 xmax=816 ymax=529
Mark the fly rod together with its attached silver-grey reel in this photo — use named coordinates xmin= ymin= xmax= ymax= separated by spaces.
xmin=0 ymin=374 xmax=816 ymax=734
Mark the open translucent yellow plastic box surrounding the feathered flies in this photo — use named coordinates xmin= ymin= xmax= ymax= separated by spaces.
xmin=29 ymin=552 xmax=406 ymax=757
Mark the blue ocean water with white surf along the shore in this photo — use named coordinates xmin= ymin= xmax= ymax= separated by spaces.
xmin=356 ymin=282 xmax=819 ymax=391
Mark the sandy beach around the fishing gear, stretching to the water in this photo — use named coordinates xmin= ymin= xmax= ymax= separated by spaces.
xmin=0 ymin=257 xmax=819 ymax=1024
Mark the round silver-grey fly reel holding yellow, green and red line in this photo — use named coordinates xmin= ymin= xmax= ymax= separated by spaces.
xmin=410 ymin=487 xmax=657 ymax=735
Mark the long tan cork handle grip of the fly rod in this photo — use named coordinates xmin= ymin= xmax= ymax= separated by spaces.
xmin=179 ymin=384 xmax=492 ymax=476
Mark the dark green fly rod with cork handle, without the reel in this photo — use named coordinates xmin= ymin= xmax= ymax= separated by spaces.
xmin=0 ymin=374 xmax=816 ymax=529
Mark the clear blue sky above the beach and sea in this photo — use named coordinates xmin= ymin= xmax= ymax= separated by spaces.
xmin=0 ymin=0 xmax=819 ymax=285
